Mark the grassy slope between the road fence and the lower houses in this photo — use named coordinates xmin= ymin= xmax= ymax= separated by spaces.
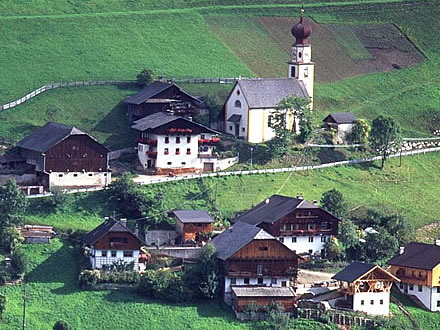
xmin=27 ymin=154 xmax=440 ymax=239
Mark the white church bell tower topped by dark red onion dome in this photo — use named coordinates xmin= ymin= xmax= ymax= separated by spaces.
xmin=288 ymin=9 xmax=315 ymax=109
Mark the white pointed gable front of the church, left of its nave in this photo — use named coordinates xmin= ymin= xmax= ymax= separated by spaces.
xmin=225 ymin=84 xmax=250 ymax=142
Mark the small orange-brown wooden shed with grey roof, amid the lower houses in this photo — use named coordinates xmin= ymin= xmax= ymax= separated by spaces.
xmin=170 ymin=210 xmax=214 ymax=244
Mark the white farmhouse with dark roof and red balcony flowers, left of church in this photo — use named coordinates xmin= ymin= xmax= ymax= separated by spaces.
xmin=132 ymin=112 xmax=220 ymax=174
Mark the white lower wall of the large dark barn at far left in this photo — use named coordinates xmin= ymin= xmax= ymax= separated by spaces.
xmin=49 ymin=172 xmax=111 ymax=187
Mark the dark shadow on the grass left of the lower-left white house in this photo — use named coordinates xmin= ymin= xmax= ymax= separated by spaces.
xmin=25 ymin=241 xmax=80 ymax=294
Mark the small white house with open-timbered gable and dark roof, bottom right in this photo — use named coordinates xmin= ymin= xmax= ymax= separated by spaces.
xmin=329 ymin=262 xmax=400 ymax=315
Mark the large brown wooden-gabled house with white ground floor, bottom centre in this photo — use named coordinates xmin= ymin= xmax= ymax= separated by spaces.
xmin=212 ymin=222 xmax=301 ymax=303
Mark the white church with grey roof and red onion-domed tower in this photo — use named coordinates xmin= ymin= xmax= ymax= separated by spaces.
xmin=224 ymin=10 xmax=315 ymax=143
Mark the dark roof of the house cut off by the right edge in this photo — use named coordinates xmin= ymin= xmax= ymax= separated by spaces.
xmin=388 ymin=242 xmax=440 ymax=270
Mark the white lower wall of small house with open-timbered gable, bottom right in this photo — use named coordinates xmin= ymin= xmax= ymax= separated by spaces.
xmin=353 ymin=292 xmax=390 ymax=315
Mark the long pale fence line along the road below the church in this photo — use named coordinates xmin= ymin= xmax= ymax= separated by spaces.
xmin=26 ymin=147 xmax=440 ymax=198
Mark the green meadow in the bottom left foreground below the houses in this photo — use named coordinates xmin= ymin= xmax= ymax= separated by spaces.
xmin=0 ymin=239 xmax=250 ymax=330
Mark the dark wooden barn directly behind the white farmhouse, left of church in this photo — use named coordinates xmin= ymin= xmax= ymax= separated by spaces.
xmin=124 ymin=81 xmax=203 ymax=121
